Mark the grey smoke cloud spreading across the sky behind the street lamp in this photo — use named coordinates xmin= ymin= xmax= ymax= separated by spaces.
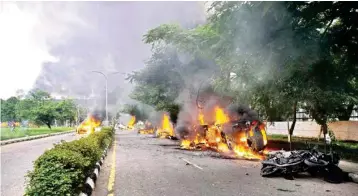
xmin=8 ymin=2 xmax=205 ymax=115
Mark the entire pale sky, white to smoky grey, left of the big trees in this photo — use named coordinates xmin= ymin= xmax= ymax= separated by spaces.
xmin=0 ymin=2 xmax=205 ymax=99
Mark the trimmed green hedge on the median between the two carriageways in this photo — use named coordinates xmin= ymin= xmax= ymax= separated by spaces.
xmin=25 ymin=127 xmax=114 ymax=196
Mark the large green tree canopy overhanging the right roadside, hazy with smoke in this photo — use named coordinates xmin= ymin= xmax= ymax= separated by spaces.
xmin=129 ymin=2 xmax=358 ymax=135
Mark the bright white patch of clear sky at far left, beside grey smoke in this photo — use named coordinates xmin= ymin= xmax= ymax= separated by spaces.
xmin=0 ymin=2 xmax=58 ymax=98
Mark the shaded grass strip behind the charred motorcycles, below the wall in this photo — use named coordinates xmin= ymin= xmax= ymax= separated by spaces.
xmin=267 ymin=135 xmax=358 ymax=162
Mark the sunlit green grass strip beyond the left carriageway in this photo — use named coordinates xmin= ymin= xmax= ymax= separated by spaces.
xmin=0 ymin=127 xmax=74 ymax=141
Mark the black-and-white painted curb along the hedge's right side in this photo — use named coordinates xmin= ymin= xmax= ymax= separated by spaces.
xmin=79 ymin=145 xmax=111 ymax=196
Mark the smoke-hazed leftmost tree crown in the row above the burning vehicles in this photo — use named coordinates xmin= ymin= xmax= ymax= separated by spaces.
xmin=127 ymin=47 xmax=215 ymax=123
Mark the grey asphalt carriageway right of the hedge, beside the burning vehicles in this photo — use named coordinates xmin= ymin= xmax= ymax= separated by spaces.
xmin=93 ymin=131 xmax=358 ymax=196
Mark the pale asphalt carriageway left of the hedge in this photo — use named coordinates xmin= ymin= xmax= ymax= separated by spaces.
xmin=0 ymin=133 xmax=80 ymax=196
